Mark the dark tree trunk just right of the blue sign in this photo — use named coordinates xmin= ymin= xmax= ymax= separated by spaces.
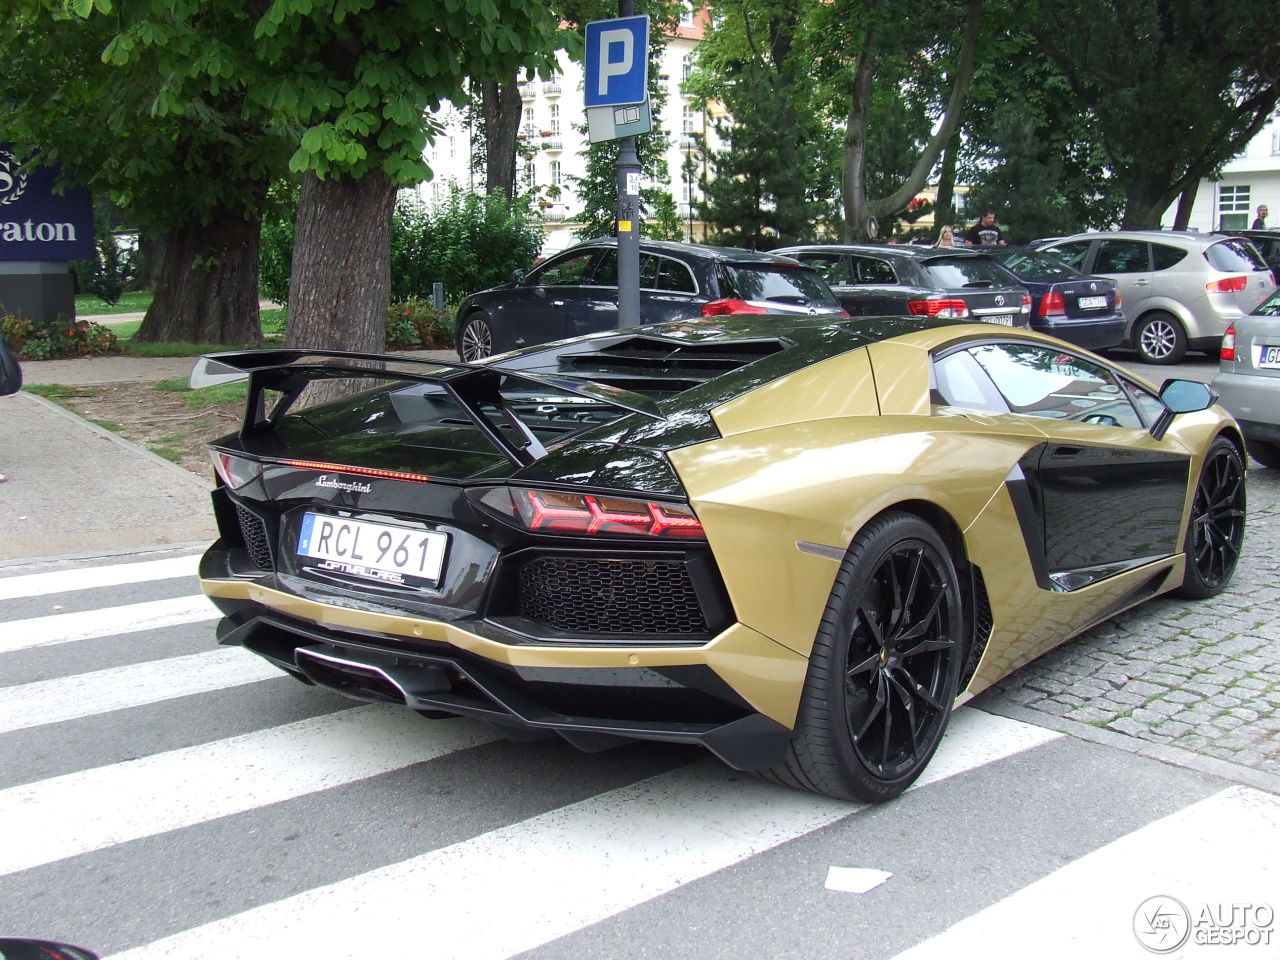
xmin=133 ymin=205 xmax=262 ymax=347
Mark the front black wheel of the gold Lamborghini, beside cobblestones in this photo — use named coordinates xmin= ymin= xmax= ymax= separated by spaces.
xmin=1179 ymin=436 xmax=1245 ymax=599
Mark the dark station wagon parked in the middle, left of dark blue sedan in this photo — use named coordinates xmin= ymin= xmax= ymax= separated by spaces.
xmin=773 ymin=244 xmax=1032 ymax=326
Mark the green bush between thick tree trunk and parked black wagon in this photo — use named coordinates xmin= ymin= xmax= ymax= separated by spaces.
xmin=390 ymin=192 xmax=543 ymax=302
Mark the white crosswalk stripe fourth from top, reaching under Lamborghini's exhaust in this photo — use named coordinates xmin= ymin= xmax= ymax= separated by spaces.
xmin=0 ymin=705 xmax=495 ymax=874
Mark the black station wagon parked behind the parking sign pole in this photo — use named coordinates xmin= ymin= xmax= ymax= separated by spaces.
xmin=457 ymin=239 xmax=840 ymax=362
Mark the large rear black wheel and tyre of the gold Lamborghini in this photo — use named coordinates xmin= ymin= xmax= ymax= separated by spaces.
xmin=769 ymin=511 xmax=965 ymax=803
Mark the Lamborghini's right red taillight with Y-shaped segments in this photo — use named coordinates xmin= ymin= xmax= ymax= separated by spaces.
xmin=480 ymin=486 xmax=705 ymax=540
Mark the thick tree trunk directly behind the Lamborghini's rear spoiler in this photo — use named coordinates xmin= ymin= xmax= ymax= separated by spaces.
xmin=284 ymin=172 xmax=396 ymax=353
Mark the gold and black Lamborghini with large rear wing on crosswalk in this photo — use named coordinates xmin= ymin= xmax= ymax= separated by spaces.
xmin=193 ymin=316 xmax=1244 ymax=801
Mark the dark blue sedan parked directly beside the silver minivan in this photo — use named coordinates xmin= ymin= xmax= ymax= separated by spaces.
xmin=988 ymin=247 xmax=1126 ymax=349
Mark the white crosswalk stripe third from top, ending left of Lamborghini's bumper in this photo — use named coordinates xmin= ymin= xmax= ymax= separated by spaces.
xmin=0 ymin=646 xmax=284 ymax=733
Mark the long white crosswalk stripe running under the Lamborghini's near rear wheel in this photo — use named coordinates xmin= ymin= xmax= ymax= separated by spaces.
xmin=99 ymin=710 xmax=1060 ymax=960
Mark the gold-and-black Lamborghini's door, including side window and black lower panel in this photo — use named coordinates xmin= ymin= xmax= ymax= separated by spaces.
xmin=934 ymin=340 xmax=1190 ymax=591
